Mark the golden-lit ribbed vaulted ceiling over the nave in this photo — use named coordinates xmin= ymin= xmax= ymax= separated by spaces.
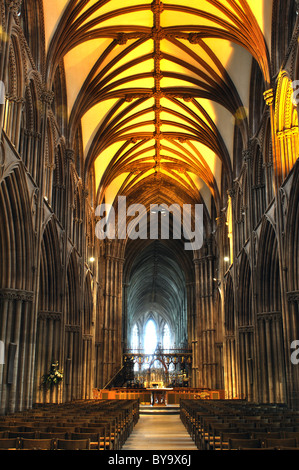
xmin=44 ymin=0 xmax=272 ymax=218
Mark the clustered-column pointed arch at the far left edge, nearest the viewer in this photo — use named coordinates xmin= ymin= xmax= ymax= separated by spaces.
xmin=0 ymin=162 xmax=37 ymax=413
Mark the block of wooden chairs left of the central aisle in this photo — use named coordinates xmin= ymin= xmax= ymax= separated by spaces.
xmin=0 ymin=400 xmax=139 ymax=450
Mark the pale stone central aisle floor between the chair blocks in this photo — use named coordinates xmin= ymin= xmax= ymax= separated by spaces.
xmin=122 ymin=410 xmax=198 ymax=451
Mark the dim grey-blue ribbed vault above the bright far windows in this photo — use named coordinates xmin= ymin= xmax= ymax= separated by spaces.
xmin=127 ymin=240 xmax=187 ymax=343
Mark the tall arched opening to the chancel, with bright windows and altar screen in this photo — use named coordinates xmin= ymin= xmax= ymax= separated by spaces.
xmin=124 ymin=240 xmax=191 ymax=385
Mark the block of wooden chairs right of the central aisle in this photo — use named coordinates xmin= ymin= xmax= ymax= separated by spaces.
xmin=180 ymin=400 xmax=299 ymax=450
